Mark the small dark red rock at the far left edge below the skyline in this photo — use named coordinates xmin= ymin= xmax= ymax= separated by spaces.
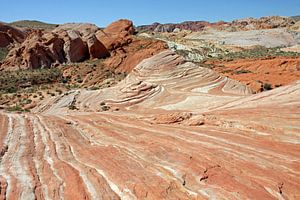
xmin=0 ymin=23 xmax=27 ymax=47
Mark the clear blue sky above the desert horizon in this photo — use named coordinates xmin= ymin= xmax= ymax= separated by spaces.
xmin=0 ymin=0 xmax=300 ymax=26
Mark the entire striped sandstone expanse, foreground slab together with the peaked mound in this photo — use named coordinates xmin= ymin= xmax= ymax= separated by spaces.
xmin=0 ymin=51 xmax=300 ymax=199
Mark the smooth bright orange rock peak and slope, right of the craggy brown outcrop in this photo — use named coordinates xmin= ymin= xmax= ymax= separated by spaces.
xmin=96 ymin=19 xmax=167 ymax=73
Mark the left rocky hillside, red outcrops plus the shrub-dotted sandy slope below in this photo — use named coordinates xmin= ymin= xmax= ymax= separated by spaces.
xmin=0 ymin=20 xmax=167 ymax=110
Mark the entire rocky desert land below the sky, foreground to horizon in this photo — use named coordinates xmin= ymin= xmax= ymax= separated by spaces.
xmin=0 ymin=17 xmax=300 ymax=200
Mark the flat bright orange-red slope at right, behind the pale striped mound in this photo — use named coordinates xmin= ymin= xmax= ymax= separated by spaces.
xmin=207 ymin=57 xmax=300 ymax=92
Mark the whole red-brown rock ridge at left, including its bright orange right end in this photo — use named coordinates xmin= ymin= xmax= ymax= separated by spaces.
xmin=1 ymin=20 xmax=167 ymax=72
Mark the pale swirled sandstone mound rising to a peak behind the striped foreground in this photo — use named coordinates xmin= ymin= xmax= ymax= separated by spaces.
xmin=37 ymin=50 xmax=252 ymax=113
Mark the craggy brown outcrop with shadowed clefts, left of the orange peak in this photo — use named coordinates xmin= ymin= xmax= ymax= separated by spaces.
xmin=1 ymin=24 xmax=109 ymax=70
